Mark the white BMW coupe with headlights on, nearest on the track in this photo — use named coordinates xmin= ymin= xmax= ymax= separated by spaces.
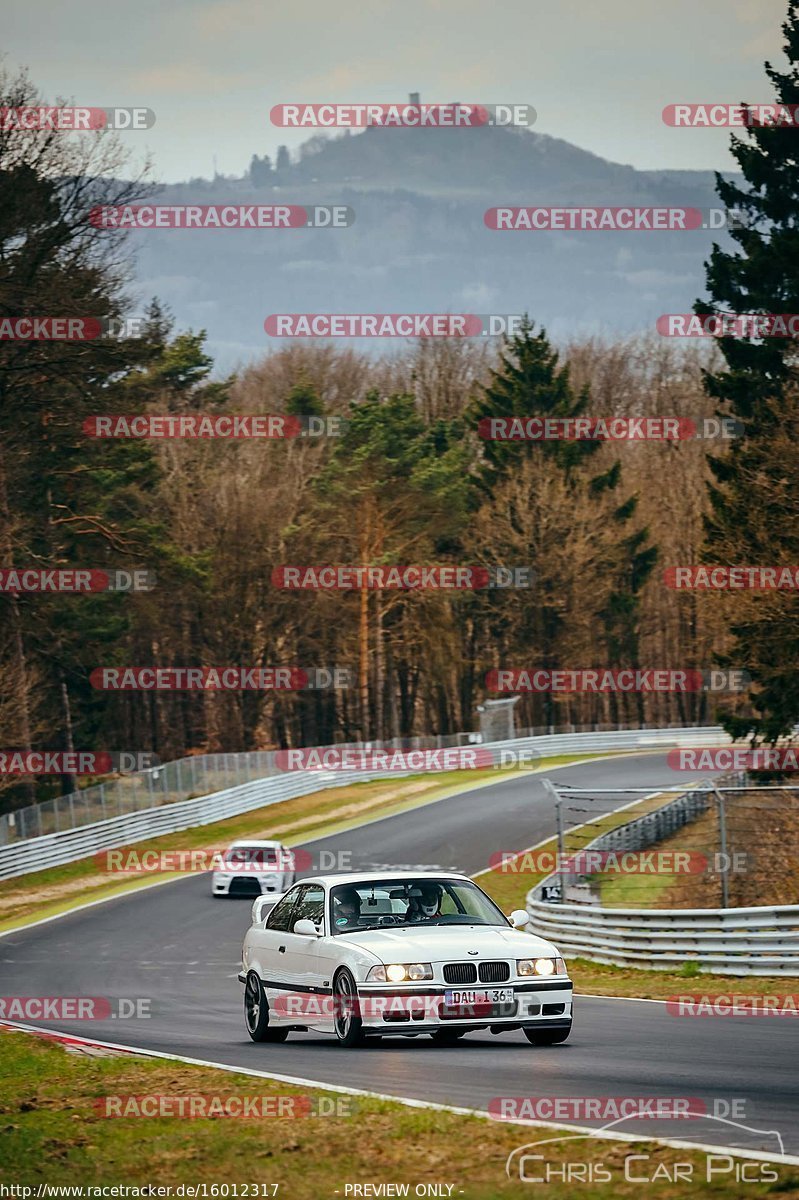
xmin=239 ymin=871 xmax=572 ymax=1046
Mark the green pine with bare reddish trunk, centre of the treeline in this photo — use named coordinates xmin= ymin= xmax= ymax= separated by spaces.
xmin=294 ymin=391 xmax=469 ymax=739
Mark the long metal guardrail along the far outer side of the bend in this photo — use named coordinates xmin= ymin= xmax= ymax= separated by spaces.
xmin=0 ymin=726 xmax=729 ymax=880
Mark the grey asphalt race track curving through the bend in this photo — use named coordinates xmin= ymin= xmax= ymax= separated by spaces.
xmin=0 ymin=754 xmax=799 ymax=1154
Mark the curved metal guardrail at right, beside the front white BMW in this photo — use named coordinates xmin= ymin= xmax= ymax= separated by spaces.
xmin=527 ymin=890 xmax=799 ymax=976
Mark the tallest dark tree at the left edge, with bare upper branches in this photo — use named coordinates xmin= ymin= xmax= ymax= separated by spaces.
xmin=0 ymin=72 xmax=202 ymax=799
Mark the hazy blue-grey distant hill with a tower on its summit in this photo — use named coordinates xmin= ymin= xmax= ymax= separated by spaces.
xmin=131 ymin=128 xmax=726 ymax=370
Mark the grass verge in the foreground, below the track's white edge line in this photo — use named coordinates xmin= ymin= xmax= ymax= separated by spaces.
xmin=0 ymin=1032 xmax=799 ymax=1200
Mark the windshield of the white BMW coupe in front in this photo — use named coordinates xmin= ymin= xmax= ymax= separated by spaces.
xmin=330 ymin=876 xmax=507 ymax=934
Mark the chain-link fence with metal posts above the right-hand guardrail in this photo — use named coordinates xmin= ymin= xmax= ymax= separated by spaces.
xmin=535 ymin=774 xmax=799 ymax=908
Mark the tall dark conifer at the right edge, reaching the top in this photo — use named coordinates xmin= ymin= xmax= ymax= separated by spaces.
xmin=695 ymin=0 xmax=799 ymax=740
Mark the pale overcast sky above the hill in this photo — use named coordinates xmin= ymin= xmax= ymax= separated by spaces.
xmin=2 ymin=0 xmax=787 ymax=181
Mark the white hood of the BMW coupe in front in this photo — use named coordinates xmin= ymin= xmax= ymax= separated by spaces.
xmin=337 ymin=925 xmax=558 ymax=962
